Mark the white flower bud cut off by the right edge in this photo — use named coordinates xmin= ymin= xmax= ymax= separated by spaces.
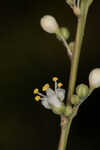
xmin=89 ymin=68 xmax=100 ymax=88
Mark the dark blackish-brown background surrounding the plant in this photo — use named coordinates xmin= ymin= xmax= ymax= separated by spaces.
xmin=0 ymin=0 xmax=100 ymax=150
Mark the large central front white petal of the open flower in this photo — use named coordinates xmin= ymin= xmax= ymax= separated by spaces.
xmin=48 ymin=95 xmax=62 ymax=107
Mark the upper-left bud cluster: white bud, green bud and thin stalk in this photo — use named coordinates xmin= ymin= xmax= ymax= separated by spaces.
xmin=40 ymin=15 xmax=72 ymax=58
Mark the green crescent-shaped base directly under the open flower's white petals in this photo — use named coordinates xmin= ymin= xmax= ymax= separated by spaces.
xmin=51 ymin=103 xmax=65 ymax=115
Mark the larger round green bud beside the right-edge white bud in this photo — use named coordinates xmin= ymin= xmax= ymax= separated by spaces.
xmin=76 ymin=84 xmax=89 ymax=98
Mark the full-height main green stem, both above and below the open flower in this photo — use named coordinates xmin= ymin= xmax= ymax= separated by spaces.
xmin=58 ymin=0 xmax=92 ymax=150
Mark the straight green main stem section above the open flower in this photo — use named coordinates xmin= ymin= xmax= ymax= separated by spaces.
xmin=67 ymin=1 xmax=88 ymax=104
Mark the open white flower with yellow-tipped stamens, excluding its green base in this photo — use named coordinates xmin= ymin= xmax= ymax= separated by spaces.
xmin=34 ymin=77 xmax=65 ymax=109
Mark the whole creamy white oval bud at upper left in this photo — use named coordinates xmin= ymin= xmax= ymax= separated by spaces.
xmin=40 ymin=15 xmax=59 ymax=33
